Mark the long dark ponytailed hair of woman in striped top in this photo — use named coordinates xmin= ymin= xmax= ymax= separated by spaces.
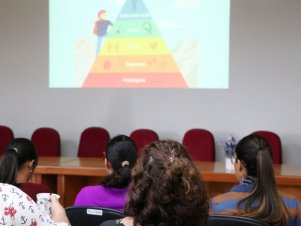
xmin=235 ymin=134 xmax=288 ymax=226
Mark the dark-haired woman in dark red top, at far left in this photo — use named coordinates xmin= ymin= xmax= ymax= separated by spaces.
xmin=0 ymin=138 xmax=50 ymax=201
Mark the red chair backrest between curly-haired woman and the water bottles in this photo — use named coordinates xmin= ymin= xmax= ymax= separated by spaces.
xmin=182 ymin=129 xmax=215 ymax=162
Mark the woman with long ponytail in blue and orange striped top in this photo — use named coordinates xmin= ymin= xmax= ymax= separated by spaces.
xmin=211 ymin=134 xmax=301 ymax=226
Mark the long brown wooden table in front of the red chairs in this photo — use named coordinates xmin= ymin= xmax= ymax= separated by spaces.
xmin=33 ymin=157 xmax=301 ymax=206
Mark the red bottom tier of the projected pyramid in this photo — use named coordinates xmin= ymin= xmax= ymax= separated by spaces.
xmin=83 ymin=72 xmax=187 ymax=88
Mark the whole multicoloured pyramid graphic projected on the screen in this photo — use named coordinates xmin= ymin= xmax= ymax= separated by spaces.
xmin=83 ymin=0 xmax=187 ymax=88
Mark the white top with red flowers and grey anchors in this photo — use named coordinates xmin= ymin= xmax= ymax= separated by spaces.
xmin=0 ymin=183 xmax=68 ymax=226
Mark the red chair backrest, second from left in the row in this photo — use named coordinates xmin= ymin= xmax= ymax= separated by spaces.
xmin=31 ymin=127 xmax=61 ymax=156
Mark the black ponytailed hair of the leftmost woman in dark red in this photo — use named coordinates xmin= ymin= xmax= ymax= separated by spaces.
xmin=0 ymin=138 xmax=38 ymax=184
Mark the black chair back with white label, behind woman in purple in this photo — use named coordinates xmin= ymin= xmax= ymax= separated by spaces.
xmin=66 ymin=206 xmax=125 ymax=226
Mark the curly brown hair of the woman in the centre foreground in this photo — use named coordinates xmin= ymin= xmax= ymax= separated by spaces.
xmin=125 ymin=141 xmax=209 ymax=226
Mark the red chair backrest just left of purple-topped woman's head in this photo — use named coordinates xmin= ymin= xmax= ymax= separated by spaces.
xmin=77 ymin=127 xmax=110 ymax=157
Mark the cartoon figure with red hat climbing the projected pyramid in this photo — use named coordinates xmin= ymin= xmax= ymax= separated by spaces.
xmin=93 ymin=9 xmax=113 ymax=55
